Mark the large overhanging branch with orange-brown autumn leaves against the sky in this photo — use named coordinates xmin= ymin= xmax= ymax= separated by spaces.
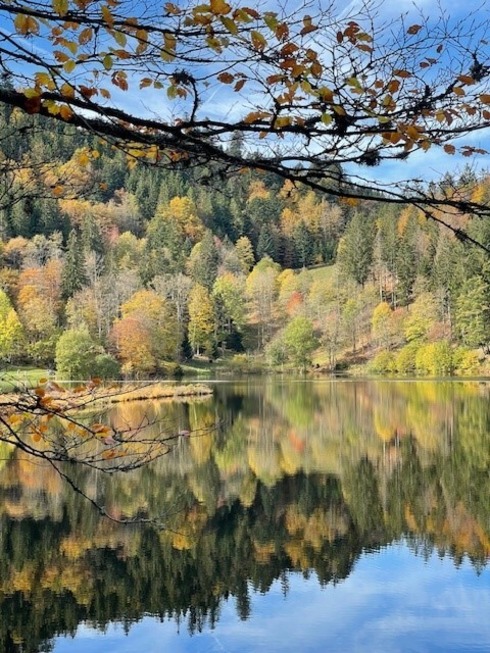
xmin=0 ymin=0 xmax=490 ymax=212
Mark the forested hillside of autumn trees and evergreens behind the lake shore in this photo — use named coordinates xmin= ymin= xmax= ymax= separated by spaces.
xmin=0 ymin=106 xmax=490 ymax=379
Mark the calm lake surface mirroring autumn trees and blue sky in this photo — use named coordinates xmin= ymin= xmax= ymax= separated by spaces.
xmin=0 ymin=380 xmax=490 ymax=653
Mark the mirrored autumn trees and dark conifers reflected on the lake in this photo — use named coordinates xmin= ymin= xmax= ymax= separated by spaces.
xmin=0 ymin=381 xmax=490 ymax=653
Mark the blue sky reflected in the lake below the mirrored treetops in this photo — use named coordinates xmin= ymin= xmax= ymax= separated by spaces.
xmin=54 ymin=545 xmax=490 ymax=653
